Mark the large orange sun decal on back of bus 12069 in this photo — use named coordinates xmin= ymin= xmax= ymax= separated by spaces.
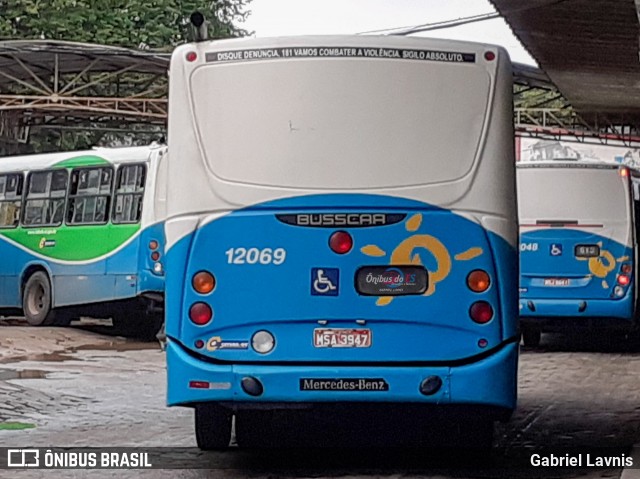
xmin=360 ymin=213 xmax=482 ymax=306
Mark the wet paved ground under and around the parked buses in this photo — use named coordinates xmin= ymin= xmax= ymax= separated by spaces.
xmin=0 ymin=320 xmax=640 ymax=478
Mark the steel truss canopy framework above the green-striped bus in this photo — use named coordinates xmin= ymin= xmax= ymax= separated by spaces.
xmin=0 ymin=40 xmax=169 ymax=152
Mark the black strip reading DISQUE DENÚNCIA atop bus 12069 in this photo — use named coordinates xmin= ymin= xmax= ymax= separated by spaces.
xmin=205 ymin=46 xmax=476 ymax=63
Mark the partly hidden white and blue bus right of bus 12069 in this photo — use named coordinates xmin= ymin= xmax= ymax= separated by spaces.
xmin=517 ymin=160 xmax=637 ymax=347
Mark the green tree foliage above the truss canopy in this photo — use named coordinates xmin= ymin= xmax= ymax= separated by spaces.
xmin=0 ymin=0 xmax=251 ymax=50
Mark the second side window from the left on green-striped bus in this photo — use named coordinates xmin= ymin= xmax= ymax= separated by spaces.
xmin=22 ymin=169 xmax=69 ymax=226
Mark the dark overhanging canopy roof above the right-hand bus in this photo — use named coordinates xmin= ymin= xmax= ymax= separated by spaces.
xmin=490 ymin=0 xmax=640 ymax=125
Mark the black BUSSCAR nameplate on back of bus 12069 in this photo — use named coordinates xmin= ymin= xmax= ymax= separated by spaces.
xmin=276 ymin=213 xmax=407 ymax=228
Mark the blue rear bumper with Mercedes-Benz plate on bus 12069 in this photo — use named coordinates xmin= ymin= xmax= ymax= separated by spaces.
xmin=167 ymin=341 xmax=518 ymax=410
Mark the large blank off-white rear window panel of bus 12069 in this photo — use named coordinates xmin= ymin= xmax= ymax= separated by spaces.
xmin=190 ymin=58 xmax=491 ymax=189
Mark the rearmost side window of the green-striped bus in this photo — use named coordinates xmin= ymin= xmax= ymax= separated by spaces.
xmin=112 ymin=164 xmax=147 ymax=224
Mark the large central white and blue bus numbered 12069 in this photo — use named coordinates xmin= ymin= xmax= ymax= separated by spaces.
xmin=165 ymin=36 xmax=518 ymax=449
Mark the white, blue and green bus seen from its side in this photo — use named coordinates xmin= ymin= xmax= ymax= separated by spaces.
xmin=0 ymin=146 xmax=166 ymax=335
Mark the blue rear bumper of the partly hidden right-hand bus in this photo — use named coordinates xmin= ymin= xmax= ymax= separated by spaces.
xmin=520 ymin=292 xmax=633 ymax=321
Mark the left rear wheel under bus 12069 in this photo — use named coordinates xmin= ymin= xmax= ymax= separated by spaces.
xmin=195 ymin=404 xmax=232 ymax=451
